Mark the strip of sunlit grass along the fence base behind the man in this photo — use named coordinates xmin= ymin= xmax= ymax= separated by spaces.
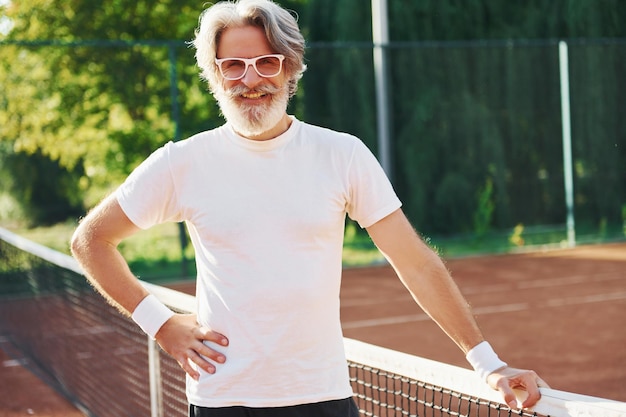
xmin=2 ymin=218 xmax=626 ymax=282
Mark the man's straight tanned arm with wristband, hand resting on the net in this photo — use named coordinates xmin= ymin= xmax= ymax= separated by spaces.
xmin=367 ymin=209 xmax=547 ymax=408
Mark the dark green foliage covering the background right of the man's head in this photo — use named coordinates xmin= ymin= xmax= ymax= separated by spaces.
xmin=304 ymin=0 xmax=626 ymax=236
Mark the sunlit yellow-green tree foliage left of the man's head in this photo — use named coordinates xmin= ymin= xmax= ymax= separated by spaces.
xmin=0 ymin=0 xmax=220 ymax=216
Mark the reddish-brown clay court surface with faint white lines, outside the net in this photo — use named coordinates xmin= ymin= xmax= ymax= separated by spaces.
xmin=0 ymin=239 xmax=626 ymax=417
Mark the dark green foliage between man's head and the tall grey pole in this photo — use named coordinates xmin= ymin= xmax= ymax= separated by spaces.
xmin=302 ymin=0 xmax=377 ymax=151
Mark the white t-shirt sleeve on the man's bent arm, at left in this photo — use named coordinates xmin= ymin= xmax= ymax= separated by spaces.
xmin=116 ymin=142 xmax=182 ymax=229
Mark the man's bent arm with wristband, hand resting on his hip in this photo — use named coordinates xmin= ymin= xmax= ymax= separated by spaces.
xmin=71 ymin=195 xmax=228 ymax=378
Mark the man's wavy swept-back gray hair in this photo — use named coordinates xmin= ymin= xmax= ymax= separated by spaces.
xmin=191 ymin=0 xmax=306 ymax=97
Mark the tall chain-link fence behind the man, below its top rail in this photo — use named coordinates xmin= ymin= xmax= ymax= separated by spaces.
xmin=0 ymin=40 xmax=626 ymax=254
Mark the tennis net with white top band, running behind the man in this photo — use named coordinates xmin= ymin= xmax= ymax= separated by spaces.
xmin=0 ymin=228 xmax=626 ymax=417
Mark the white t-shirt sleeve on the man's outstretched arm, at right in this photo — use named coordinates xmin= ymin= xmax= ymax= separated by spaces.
xmin=347 ymin=140 xmax=402 ymax=228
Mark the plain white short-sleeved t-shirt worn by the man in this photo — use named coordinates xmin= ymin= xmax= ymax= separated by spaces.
xmin=117 ymin=117 xmax=401 ymax=407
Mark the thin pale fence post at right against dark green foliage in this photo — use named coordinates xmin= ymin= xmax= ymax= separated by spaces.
xmin=559 ymin=41 xmax=576 ymax=247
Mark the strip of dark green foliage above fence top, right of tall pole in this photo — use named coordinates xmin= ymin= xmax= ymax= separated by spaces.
xmin=382 ymin=0 xmax=626 ymax=41
